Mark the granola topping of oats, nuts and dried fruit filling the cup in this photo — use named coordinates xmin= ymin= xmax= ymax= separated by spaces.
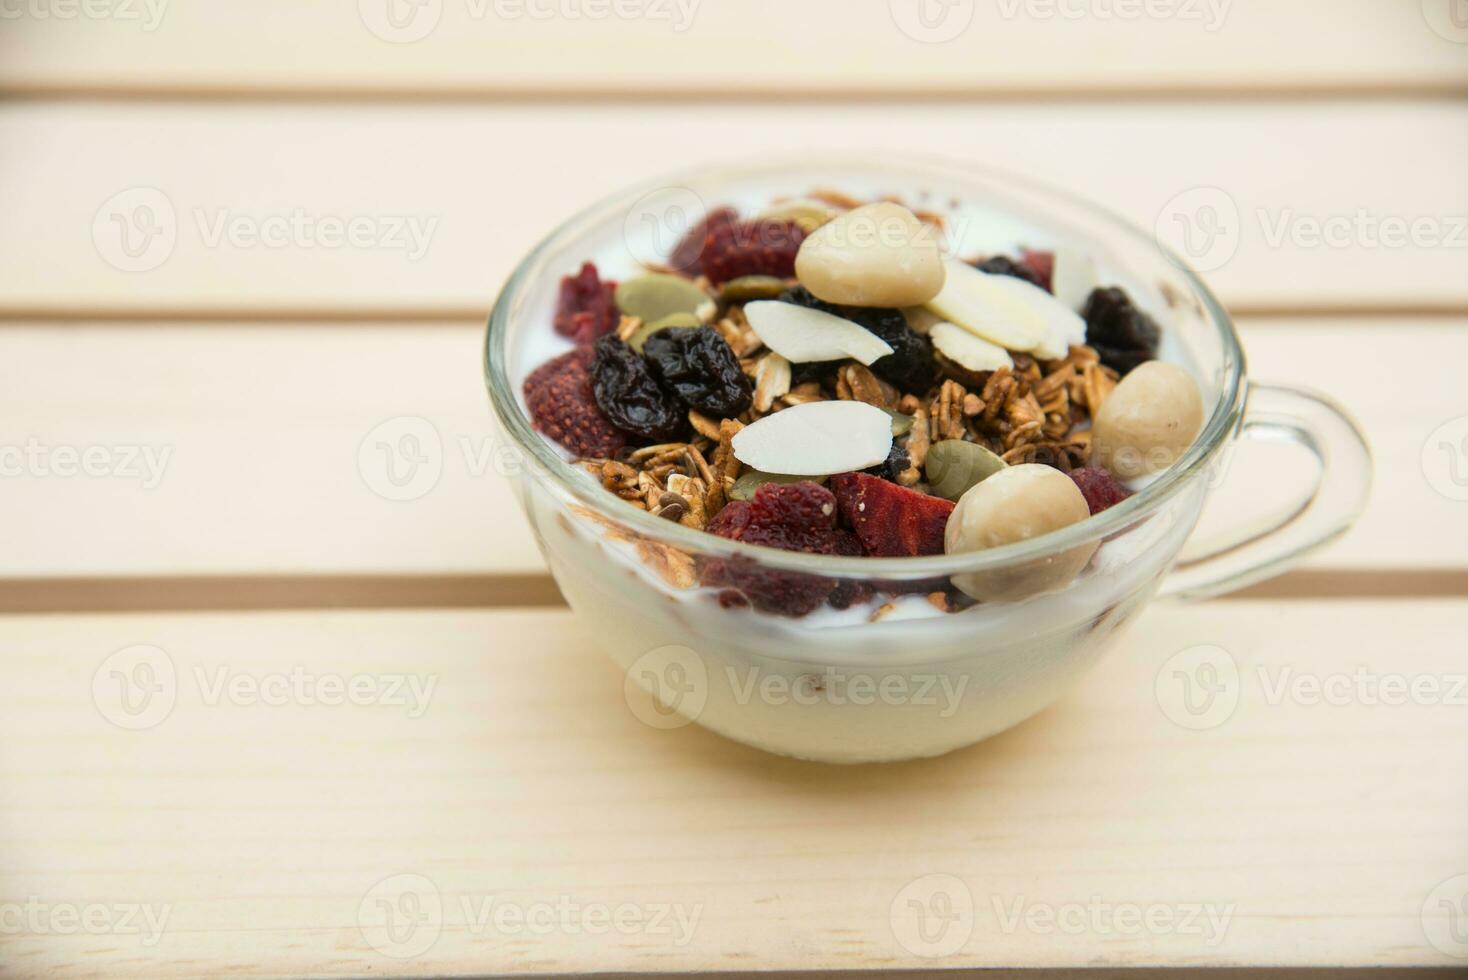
xmin=526 ymin=194 xmax=1201 ymax=615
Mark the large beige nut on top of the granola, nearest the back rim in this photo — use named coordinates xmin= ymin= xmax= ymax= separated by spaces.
xmin=796 ymin=201 xmax=945 ymax=307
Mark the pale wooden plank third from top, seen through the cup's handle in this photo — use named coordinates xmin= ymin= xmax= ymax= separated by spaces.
xmin=0 ymin=318 xmax=1468 ymax=609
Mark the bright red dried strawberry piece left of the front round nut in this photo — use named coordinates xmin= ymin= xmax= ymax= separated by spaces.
xmin=831 ymin=472 xmax=953 ymax=557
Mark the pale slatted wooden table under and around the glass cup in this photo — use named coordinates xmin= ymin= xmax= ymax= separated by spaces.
xmin=0 ymin=0 xmax=1468 ymax=977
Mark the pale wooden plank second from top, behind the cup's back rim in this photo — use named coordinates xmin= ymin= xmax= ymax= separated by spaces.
xmin=0 ymin=103 xmax=1468 ymax=320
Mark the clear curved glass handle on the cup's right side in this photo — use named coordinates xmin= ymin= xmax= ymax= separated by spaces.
xmin=1158 ymin=384 xmax=1371 ymax=599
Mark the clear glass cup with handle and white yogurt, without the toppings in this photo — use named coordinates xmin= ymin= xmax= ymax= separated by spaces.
xmin=484 ymin=160 xmax=1371 ymax=763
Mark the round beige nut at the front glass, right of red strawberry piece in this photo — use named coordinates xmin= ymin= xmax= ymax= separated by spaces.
xmin=944 ymin=464 xmax=1100 ymax=601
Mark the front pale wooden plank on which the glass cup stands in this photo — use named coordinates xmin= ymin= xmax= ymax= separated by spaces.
xmin=0 ymin=600 xmax=1468 ymax=980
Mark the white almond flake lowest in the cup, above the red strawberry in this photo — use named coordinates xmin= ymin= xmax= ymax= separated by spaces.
xmin=734 ymin=402 xmax=893 ymax=475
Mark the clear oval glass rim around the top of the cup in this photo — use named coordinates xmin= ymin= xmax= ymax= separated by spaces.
xmin=483 ymin=154 xmax=1245 ymax=581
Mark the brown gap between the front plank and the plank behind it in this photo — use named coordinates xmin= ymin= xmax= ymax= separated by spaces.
xmin=0 ymin=569 xmax=1468 ymax=615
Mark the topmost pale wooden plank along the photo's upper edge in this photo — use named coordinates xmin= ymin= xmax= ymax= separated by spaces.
xmin=0 ymin=0 xmax=1468 ymax=98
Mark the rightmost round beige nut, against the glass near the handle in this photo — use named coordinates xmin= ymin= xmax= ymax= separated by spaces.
xmin=1091 ymin=361 xmax=1202 ymax=480
